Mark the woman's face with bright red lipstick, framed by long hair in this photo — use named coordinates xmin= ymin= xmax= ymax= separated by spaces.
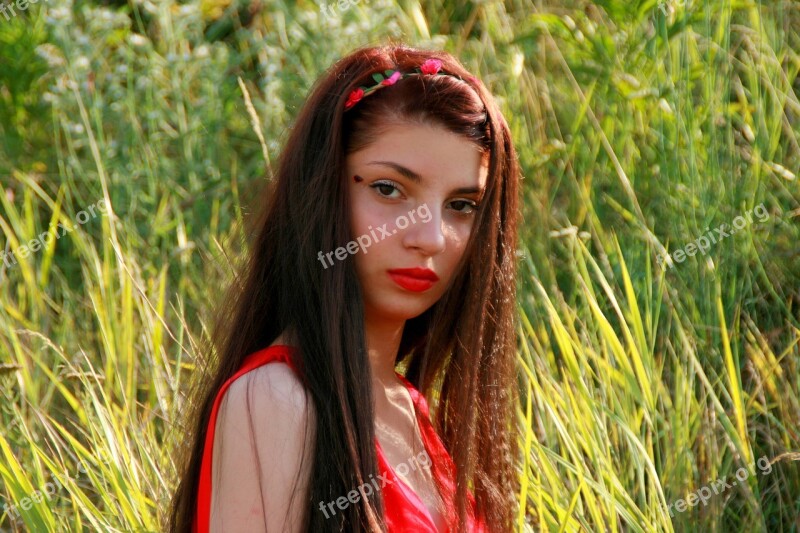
xmin=340 ymin=123 xmax=488 ymax=321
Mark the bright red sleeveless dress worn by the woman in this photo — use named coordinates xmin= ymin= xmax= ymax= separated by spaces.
xmin=192 ymin=345 xmax=486 ymax=533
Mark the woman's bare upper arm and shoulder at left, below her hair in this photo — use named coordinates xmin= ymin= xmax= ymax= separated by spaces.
xmin=210 ymin=363 xmax=316 ymax=533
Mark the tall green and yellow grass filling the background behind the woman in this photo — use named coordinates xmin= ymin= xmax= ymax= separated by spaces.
xmin=0 ymin=0 xmax=800 ymax=532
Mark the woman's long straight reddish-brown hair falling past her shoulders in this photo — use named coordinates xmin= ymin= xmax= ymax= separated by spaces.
xmin=169 ymin=45 xmax=519 ymax=532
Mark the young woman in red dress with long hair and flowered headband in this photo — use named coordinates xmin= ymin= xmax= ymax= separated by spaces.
xmin=169 ymin=46 xmax=519 ymax=533
